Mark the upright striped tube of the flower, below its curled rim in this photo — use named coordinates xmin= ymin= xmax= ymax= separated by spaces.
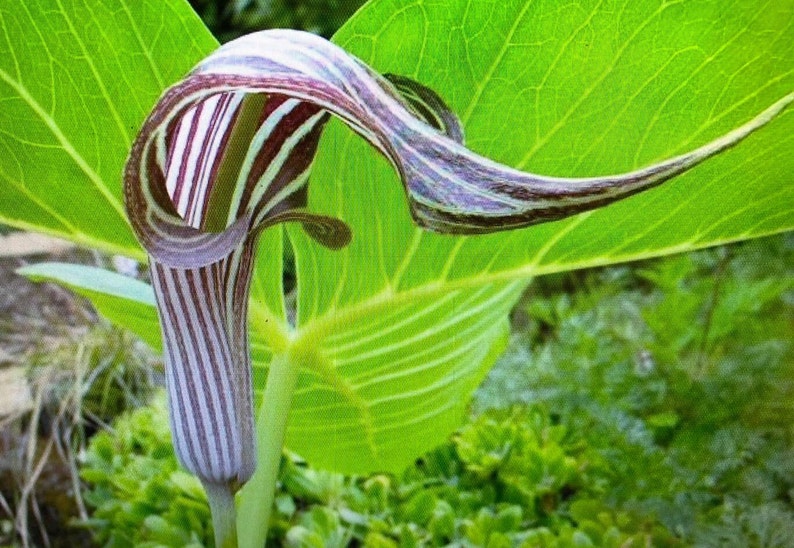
xmin=150 ymin=250 xmax=256 ymax=485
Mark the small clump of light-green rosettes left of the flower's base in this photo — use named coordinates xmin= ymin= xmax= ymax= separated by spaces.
xmin=80 ymin=393 xmax=212 ymax=546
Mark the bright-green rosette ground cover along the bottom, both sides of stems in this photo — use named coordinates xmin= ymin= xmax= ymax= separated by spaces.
xmin=81 ymin=394 xmax=675 ymax=548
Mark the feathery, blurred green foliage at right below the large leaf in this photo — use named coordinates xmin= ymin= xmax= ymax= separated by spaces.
xmin=474 ymin=233 xmax=794 ymax=546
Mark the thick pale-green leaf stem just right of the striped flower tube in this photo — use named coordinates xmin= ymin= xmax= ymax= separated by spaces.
xmin=237 ymin=354 xmax=299 ymax=548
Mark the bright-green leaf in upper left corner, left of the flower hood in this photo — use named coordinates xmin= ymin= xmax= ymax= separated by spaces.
xmin=0 ymin=0 xmax=217 ymax=258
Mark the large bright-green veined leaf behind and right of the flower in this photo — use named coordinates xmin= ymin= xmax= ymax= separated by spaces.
xmin=276 ymin=0 xmax=794 ymax=471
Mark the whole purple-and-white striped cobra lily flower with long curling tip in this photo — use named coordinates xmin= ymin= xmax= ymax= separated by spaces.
xmin=124 ymin=30 xmax=794 ymax=544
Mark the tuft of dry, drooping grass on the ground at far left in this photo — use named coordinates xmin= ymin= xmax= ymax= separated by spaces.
xmin=0 ymin=323 xmax=158 ymax=546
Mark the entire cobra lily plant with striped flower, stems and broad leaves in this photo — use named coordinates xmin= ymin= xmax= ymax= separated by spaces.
xmin=0 ymin=0 xmax=794 ymax=546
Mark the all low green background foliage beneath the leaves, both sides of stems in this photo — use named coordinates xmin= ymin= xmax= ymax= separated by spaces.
xmin=83 ymin=236 xmax=794 ymax=547
